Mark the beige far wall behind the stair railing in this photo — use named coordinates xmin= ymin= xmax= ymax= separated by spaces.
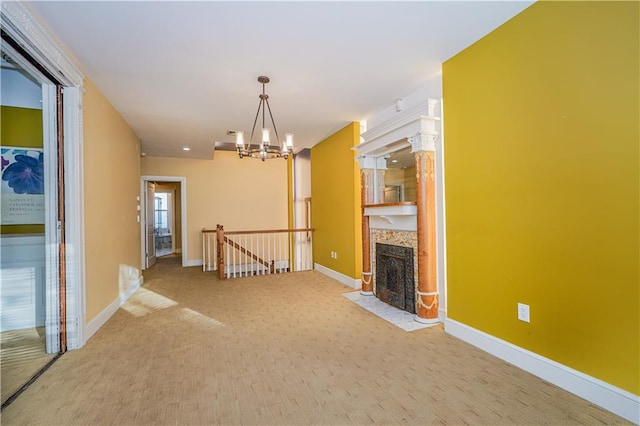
xmin=143 ymin=151 xmax=288 ymax=264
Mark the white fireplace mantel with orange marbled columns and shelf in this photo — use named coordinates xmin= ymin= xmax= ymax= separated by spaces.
xmin=355 ymin=98 xmax=441 ymax=324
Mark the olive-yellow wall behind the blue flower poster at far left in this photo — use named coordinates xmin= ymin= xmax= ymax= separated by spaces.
xmin=0 ymin=105 xmax=44 ymax=234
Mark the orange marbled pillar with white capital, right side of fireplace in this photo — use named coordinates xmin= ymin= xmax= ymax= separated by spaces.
xmin=408 ymin=99 xmax=439 ymax=323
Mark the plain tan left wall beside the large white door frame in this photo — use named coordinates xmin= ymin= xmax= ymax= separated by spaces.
xmin=83 ymin=80 xmax=140 ymax=321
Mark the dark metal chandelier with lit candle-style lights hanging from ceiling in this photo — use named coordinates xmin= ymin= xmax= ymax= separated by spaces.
xmin=236 ymin=75 xmax=293 ymax=161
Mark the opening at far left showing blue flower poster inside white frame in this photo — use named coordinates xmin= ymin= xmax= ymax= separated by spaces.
xmin=0 ymin=46 xmax=59 ymax=404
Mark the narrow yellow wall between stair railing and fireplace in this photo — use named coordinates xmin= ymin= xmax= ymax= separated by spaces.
xmin=311 ymin=123 xmax=362 ymax=279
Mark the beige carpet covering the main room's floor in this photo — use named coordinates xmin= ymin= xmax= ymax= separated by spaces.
xmin=1 ymin=255 xmax=625 ymax=425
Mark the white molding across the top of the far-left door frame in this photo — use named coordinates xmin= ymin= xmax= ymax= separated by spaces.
xmin=0 ymin=1 xmax=84 ymax=87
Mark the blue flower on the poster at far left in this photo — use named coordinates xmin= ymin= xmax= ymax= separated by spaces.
xmin=2 ymin=152 xmax=44 ymax=194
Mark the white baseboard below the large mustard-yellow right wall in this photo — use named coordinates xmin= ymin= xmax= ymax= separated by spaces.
xmin=445 ymin=319 xmax=640 ymax=424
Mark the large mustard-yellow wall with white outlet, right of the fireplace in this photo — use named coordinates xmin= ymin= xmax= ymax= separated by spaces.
xmin=443 ymin=2 xmax=640 ymax=395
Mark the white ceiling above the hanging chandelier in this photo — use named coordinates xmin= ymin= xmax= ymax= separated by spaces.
xmin=28 ymin=1 xmax=532 ymax=159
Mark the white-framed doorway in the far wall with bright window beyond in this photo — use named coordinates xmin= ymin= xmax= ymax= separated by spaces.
xmin=140 ymin=176 xmax=188 ymax=269
